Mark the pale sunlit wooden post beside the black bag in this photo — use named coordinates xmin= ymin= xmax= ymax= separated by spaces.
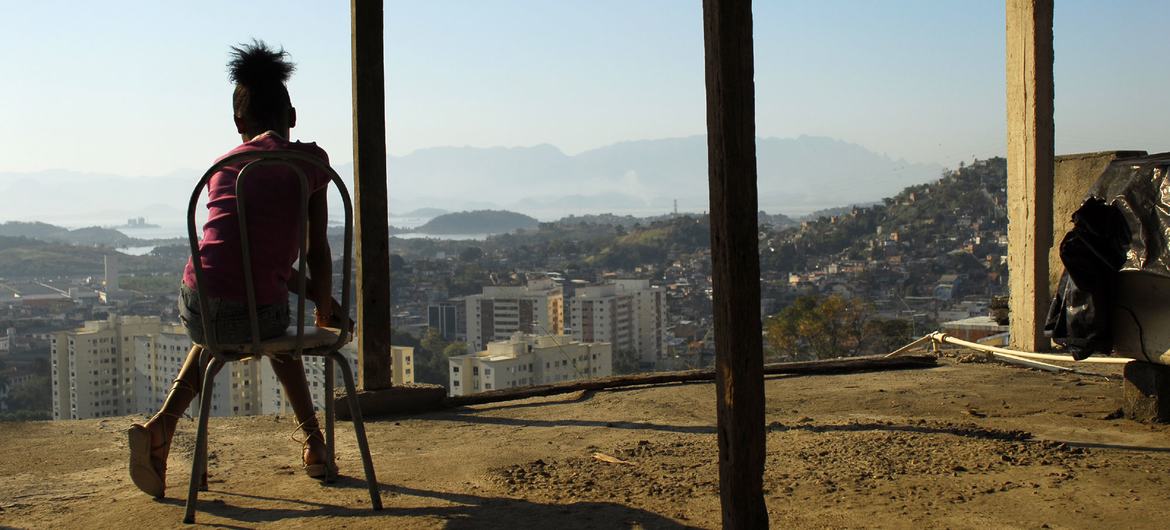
xmin=1006 ymin=0 xmax=1054 ymax=351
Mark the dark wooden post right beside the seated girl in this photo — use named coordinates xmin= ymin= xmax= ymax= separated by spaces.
xmin=350 ymin=0 xmax=391 ymax=391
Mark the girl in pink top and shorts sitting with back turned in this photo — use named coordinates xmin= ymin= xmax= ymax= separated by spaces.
xmin=129 ymin=41 xmax=344 ymax=497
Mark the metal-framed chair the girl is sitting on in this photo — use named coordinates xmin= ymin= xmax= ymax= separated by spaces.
xmin=183 ymin=151 xmax=381 ymax=524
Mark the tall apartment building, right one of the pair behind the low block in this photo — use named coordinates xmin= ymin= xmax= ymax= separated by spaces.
xmin=567 ymin=280 xmax=669 ymax=369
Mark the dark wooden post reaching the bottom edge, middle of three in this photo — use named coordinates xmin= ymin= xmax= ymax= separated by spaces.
xmin=703 ymin=0 xmax=768 ymax=529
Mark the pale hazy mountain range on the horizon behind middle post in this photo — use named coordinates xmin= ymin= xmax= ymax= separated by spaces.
xmin=362 ymin=136 xmax=943 ymax=219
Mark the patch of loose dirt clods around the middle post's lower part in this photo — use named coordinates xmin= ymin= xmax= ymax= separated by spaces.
xmin=490 ymin=419 xmax=1087 ymax=502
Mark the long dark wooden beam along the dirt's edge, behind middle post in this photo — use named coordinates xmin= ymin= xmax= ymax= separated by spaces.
xmin=442 ymin=355 xmax=938 ymax=407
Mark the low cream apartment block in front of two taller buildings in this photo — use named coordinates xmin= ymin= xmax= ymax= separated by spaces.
xmin=448 ymin=332 xmax=613 ymax=395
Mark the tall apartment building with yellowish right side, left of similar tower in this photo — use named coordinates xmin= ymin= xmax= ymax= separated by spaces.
xmin=464 ymin=278 xmax=565 ymax=350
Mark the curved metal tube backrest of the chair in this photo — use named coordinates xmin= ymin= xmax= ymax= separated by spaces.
xmin=187 ymin=151 xmax=353 ymax=356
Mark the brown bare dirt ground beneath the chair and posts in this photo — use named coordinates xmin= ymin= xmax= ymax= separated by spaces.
xmin=0 ymin=360 xmax=1170 ymax=529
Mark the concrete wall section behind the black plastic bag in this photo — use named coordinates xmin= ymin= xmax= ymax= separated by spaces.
xmin=1048 ymin=151 xmax=1145 ymax=296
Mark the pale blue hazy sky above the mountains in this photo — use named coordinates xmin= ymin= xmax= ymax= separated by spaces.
xmin=0 ymin=0 xmax=1170 ymax=175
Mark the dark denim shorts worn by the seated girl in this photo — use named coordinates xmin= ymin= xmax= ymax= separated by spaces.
xmin=179 ymin=283 xmax=290 ymax=344
